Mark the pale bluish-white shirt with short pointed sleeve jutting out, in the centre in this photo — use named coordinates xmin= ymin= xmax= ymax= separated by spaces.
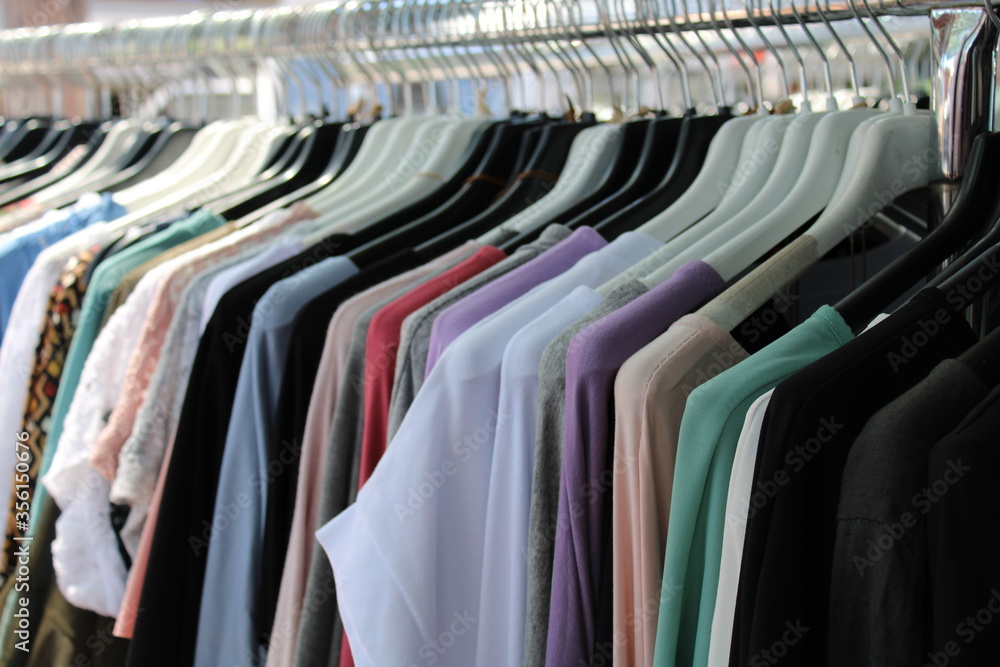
xmin=316 ymin=232 xmax=662 ymax=667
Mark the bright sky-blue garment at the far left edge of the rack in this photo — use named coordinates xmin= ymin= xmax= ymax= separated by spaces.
xmin=0 ymin=193 xmax=125 ymax=342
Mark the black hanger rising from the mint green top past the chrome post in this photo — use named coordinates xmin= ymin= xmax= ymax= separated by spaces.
xmin=835 ymin=133 xmax=1000 ymax=333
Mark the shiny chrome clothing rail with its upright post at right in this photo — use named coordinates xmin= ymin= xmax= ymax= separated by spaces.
xmin=0 ymin=0 xmax=997 ymax=179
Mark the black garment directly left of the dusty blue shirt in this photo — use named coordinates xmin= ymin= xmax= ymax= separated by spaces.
xmin=128 ymin=235 xmax=356 ymax=667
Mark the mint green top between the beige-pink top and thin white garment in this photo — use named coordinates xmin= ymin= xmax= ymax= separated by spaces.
xmin=653 ymin=306 xmax=854 ymax=667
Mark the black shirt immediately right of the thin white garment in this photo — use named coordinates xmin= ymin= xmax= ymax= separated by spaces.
xmin=730 ymin=289 xmax=976 ymax=666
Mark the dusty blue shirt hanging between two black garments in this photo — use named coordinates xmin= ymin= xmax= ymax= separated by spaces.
xmin=195 ymin=257 xmax=358 ymax=667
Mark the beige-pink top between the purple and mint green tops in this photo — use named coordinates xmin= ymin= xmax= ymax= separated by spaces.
xmin=612 ymin=315 xmax=748 ymax=667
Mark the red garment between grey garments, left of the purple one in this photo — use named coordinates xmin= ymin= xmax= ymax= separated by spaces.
xmin=340 ymin=246 xmax=507 ymax=667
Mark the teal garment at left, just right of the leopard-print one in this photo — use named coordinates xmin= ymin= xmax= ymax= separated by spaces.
xmin=29 ymin=211 xmax=226 ymax=516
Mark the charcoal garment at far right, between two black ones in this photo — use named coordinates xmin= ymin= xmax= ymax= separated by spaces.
xmin=827 ymin=360 xmax=990 ymax=664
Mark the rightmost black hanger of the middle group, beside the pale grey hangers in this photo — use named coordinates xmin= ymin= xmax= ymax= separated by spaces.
xmin=594 ymin=107 xmax=733 ymax=240
